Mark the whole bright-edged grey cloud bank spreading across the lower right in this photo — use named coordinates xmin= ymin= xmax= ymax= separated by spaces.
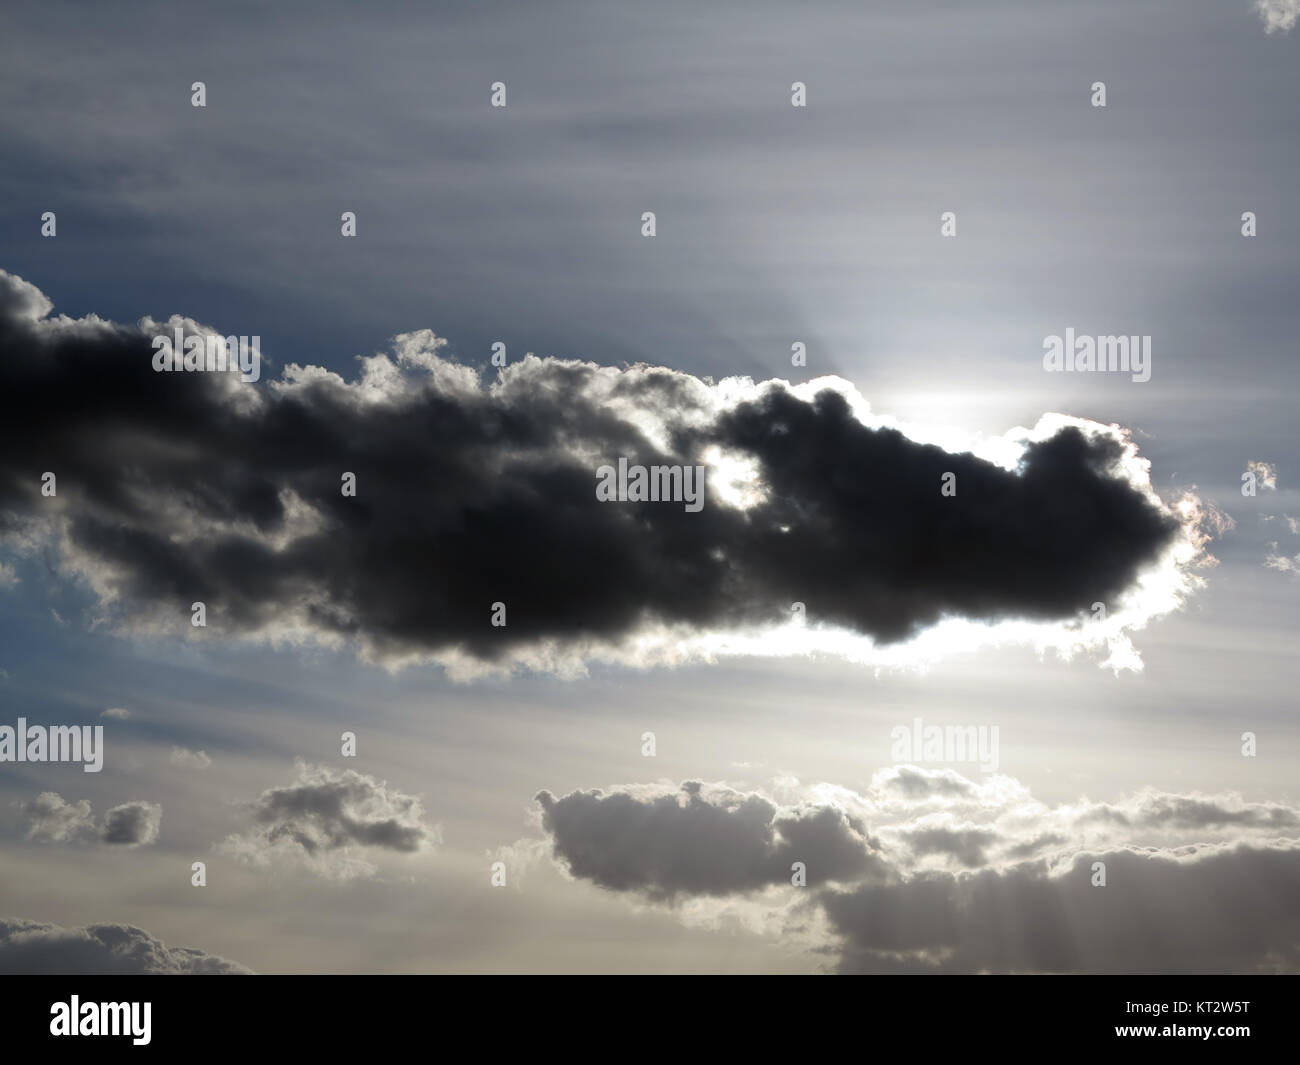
xmin=538 ymin=766 xmax=1300 ymax=973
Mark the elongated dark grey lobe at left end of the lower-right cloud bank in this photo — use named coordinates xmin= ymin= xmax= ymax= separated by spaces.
xmin=537 ymin=782 xmax=875 ymax=900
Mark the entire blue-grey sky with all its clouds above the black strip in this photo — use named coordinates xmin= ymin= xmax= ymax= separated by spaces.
xmin=0 ymin=0 xmax=1300 ymax=974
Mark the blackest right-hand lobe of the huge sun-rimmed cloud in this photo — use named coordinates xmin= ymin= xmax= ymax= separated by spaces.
xmin=691 ymin=389 xmax=1177 ymax=641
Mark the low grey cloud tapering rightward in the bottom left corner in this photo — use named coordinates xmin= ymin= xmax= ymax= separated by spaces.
xmin=0 ymin=918 xmax=251 ymax=975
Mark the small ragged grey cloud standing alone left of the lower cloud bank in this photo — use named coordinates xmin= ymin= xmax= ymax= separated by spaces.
xmin=218 ymin=762 xmax=438 ymax=879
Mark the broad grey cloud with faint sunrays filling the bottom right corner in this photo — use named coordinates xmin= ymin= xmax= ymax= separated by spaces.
xmin=820 ymin=840 xmax=1300 ymax=973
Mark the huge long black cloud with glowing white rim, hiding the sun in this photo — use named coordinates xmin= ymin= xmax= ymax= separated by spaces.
xmin=0 ymin=273 xmax=1201 ymax=676
